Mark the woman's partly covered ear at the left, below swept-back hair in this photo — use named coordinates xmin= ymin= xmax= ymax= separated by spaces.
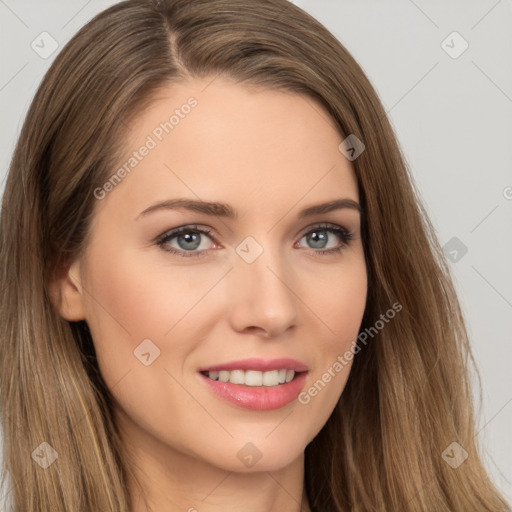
xmin=49 ymin=259 xmax=85 ymax=322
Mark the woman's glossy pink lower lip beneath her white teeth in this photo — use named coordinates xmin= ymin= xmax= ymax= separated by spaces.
xmin=199 ymin=372 xmax=307 ymax=411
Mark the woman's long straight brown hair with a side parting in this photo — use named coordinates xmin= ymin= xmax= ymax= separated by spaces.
xmin=0 ymin=0 xmax=507 ymax=512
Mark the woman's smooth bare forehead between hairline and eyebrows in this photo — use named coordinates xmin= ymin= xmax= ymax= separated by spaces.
xmin=100 ymin=77 xmax=358 ymax=218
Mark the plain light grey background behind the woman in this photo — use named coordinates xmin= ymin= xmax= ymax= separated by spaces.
xmin=0 ymin=0 xmax=512 ymax=506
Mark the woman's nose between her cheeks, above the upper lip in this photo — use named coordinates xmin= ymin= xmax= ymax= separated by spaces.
xmin=227 ymin=245 xmax=298 ymax=338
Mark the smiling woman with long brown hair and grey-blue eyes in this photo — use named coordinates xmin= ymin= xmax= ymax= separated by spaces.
xmin=0 ymin=0 xmax=507 ymax=512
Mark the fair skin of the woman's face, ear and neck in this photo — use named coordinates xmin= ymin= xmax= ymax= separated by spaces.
xmin=53 ymin=77 xmax=367 ymax=512
